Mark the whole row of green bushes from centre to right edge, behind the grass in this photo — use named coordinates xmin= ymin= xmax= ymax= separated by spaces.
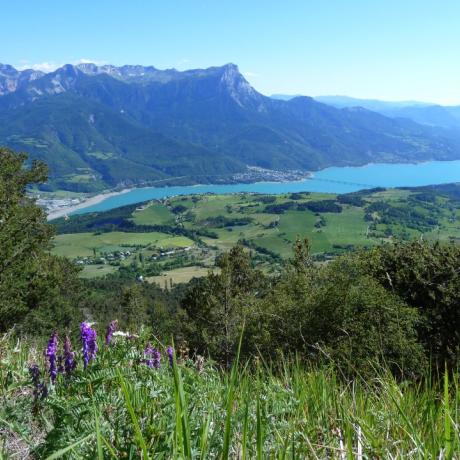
xmin=182 ymin=237 xmax=460 ymax=377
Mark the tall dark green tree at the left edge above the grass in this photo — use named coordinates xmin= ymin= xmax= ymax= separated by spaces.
xmin=0 ymin=148 xmax=83 ymax=332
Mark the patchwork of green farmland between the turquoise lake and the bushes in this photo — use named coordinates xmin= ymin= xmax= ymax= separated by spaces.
xmin=53 ymin=186 xmax=460 ymax=285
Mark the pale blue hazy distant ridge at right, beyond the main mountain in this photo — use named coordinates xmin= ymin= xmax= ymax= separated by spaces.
xmin=315 ymin=96 xmax=460 ymax=129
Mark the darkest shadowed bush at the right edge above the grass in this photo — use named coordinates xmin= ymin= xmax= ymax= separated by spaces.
xmin=363 ymin=241 xmax=460 ymax=368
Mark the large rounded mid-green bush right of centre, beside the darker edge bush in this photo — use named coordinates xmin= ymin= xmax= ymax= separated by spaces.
xmin=253 ymin=244 xmax=424 ymax=375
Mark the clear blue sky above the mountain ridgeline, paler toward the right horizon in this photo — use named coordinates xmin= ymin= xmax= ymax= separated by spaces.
xmin=0 ymin=0 xmax=460 ymax=105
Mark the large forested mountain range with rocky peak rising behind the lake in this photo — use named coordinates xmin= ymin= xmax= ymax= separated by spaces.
xmin=0 ymin=64 xmax=460 ymax=191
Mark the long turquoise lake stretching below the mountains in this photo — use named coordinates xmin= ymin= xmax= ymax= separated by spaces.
xmin=74 ymin=160 xmax=460 ymax=214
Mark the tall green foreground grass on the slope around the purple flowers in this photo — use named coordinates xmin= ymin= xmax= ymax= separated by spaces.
xmin=0 ymin=331 xmax=460 ymax=459
